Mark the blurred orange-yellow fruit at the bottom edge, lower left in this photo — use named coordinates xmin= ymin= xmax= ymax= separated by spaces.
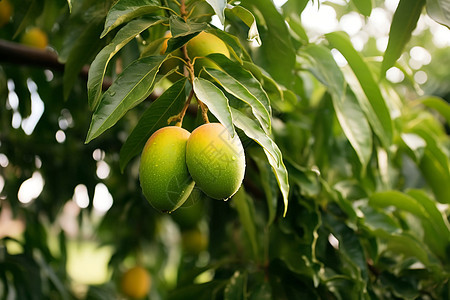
xmin=120 ymin=266 xmax=152 ymax=299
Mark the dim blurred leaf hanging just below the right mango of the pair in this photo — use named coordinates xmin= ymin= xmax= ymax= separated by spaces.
xmin=231 ymin=186 xmax=260 ymax=261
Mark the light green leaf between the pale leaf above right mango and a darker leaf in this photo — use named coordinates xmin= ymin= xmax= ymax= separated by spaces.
xmin=206 ymin=68 xmax=271 ymax=133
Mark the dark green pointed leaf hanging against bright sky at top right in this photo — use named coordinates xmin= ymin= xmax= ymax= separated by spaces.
xmin=381 ymin=0 xmax=425 ymax=77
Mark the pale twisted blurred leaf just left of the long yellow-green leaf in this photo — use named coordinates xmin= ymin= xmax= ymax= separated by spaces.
xmin=302 ymin=45 xmax=372 ymax=173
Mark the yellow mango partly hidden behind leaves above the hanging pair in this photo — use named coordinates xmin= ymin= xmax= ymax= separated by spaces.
xmin=186 ymin=31 xmax=230 ymax=74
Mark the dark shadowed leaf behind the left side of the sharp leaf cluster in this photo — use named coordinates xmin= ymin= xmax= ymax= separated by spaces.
xmin=63 ymin=18 xmax=104 ymax=99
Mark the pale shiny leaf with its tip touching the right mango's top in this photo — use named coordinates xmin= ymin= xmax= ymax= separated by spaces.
xmin=194 ymin=77 xmax=236 ymax=137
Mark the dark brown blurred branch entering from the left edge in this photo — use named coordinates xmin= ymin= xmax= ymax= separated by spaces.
xmin=0 ymin=39 xmax=111 ymax=90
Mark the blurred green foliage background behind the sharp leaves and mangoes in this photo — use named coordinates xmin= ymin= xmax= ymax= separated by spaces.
xmin=0 ymin=0 xmax=450 ymax=299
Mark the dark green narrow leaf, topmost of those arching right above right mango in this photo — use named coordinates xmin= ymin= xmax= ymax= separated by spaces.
xmin=207 ymin=53 xmax=272 ymax=115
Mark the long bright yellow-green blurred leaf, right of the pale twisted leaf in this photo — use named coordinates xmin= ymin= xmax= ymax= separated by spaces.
xmin=325 ymin=32 xmax=392 ymax=148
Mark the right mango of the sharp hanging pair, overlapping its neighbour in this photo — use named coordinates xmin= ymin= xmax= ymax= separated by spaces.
xmin=186 ymin=123 xmax=245 ymax=199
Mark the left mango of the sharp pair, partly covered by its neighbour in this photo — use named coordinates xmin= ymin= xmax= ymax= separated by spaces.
xmin=139 ymin=126 xmax=195 ymax=212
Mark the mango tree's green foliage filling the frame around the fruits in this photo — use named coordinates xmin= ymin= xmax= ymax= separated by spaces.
xmin=0 ymin=0 xmax=450 ymax=300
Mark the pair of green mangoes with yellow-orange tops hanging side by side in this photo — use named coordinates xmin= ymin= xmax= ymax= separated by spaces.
xmin=139 ymin=123 xmax=245 ymax=212
